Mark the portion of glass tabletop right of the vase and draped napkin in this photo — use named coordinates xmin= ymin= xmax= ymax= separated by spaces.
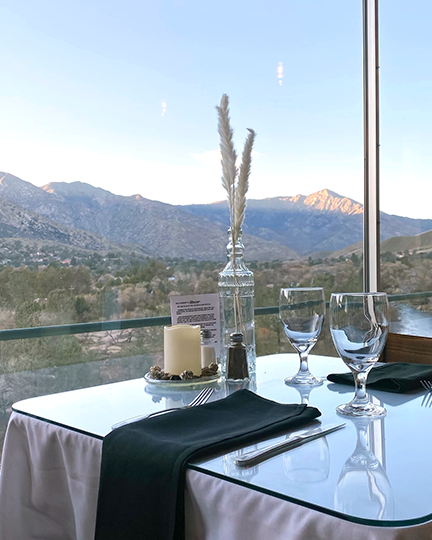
xmin=191 ymin=356 xmax=432 ymax=527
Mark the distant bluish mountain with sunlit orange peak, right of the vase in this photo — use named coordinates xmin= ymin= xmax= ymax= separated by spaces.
xmin=183 ymin=189 xmax=432 ymax=256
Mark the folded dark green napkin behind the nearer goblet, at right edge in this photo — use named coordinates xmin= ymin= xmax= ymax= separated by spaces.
xmin=327 ymin=362 xmax=432 ymax=394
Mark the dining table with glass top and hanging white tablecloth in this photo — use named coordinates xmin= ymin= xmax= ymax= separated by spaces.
xmin=0 ymin=354 xmax=432 ymax=540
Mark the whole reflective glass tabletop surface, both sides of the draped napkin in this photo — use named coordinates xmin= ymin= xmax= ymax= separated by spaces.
xmin=13 ymin=354 xmax=432 ymax=527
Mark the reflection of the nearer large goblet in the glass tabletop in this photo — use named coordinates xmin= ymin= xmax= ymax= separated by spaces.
xmin=335 ymin=418 xmax=394 ymax=521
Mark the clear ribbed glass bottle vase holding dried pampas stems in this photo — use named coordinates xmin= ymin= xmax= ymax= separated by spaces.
xmin=218 ymin=229 xmax=256 ymax=377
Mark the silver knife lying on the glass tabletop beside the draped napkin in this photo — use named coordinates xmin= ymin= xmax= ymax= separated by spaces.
xmin=234 ymin=424 xmax=346 ymax=467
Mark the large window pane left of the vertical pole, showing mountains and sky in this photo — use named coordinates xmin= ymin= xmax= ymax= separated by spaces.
xmin=0 ymin=0 xmax=363 ymax=450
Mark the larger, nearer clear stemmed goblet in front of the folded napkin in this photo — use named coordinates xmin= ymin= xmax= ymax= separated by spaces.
xmin=330 ymin=292 xmax=390 ymax=417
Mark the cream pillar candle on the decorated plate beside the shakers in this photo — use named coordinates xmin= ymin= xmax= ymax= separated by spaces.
xmin=164 ymin=324 xmax=201 ymax=375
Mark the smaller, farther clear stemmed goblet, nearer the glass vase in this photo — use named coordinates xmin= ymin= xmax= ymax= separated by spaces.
xmin=279 ymin=287 xmax=325 ymax=386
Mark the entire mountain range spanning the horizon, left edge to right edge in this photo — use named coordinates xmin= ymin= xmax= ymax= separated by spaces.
xmin=0 ymin=172 xmax=432 ymax=260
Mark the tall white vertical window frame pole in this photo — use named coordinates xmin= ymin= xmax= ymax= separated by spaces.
xmin=363 ymin=0 xmax=380 ymax=292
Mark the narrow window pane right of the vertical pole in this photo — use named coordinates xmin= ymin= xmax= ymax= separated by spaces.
xmin=380 ymin=0 xmax=432 ymax=336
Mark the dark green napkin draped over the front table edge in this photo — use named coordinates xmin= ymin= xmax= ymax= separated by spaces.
xmin=95 ymin=390 xmax=321 ymax=540
